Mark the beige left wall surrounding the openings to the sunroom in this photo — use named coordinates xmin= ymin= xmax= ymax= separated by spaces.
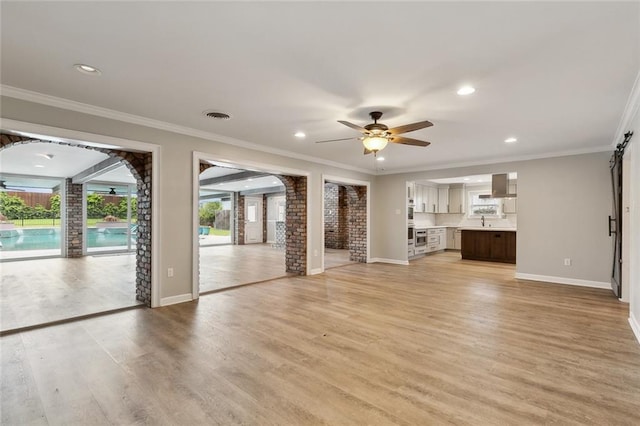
xmin=0 ymin=97 xmax=372 ymax=300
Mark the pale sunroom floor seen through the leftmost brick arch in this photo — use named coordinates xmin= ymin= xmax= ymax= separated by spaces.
xmin=0 ymin=254 xmax=140 ymax=331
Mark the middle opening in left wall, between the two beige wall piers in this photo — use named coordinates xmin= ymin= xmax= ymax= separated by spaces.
xmin=194 ymin=159 xmax=307 ymax=297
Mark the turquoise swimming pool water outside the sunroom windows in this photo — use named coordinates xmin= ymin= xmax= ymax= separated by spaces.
xmin=0 ymin=228 xmax=135 ymax=251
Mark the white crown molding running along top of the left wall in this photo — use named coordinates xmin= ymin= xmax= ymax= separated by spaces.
xmin=0 ymin=84 xmax=376 ymax=175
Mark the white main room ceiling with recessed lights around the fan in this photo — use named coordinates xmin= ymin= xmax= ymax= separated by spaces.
xmin=1 ymin=1 xmax=640 ymax=172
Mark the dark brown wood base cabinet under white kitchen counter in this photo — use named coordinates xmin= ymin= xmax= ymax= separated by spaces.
xmin=461 ymin=229 xmax=516 ymax=263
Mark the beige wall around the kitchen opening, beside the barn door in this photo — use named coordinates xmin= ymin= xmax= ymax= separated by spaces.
xmin=372 ymin=152 xmax=612 ymax=288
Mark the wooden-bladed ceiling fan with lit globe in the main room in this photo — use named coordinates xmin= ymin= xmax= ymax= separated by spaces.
xmin=316 ymin=111 xmax=433 ymax=156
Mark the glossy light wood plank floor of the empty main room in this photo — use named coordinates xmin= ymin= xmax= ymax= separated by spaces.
xmin=0 ymin=253 xmax=640 ymax=425
